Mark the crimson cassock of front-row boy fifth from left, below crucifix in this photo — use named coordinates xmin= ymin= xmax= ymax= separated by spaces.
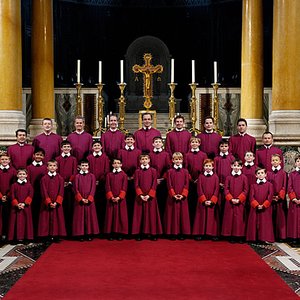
xmin=132 ymin=168 xmax=162 ymax=235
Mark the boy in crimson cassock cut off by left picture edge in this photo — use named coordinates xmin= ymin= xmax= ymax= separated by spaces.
xmin=0 ymin=152 xmax=17 ymax=241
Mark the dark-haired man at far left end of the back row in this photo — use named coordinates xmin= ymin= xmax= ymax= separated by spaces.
xmin=7 ymin=129 xmax=34 ymax=170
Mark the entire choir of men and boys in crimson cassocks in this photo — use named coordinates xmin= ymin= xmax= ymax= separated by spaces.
xmin=0 ymin=113 xmax=300 ymax=243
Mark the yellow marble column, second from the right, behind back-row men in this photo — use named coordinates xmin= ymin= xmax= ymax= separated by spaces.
xmin=241 ymin=0 xmax=266 ymax=140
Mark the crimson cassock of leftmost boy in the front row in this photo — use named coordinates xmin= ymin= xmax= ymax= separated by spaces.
xmin=8 ymin=182 xmax=33 ymax=241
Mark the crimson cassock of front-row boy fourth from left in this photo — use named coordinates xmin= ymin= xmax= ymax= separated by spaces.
xmin=104 ymin=171 xmax=128 ymax=234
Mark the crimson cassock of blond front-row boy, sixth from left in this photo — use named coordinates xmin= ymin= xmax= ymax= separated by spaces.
xmin=164 ymin=168 xmax=191 ymax=234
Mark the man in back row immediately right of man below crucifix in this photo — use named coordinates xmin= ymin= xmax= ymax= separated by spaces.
xmin=166 ymin=115 xmax=192 ymax=156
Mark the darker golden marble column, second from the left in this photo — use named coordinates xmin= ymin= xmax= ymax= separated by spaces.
xmin=29 ymin=0 xmax=55 ymax=138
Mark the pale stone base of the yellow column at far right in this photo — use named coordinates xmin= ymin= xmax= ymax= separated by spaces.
xmin=269 ymin=110 xmax=300 ymax=146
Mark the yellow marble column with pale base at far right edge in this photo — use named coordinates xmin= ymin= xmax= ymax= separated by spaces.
xmin=270 ymin=0 xmax=300 ymax=145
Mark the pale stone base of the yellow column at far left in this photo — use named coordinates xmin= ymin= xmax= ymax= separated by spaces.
xmin=0 ymin=110 xmax=26 ymax=146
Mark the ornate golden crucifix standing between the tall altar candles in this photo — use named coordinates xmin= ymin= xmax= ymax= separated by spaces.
xmin=132 ymin=53 xmax=164 ymax=110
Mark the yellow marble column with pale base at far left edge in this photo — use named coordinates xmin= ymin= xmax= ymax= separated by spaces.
xmin=0 ymin=0 xmax=26 ymax=145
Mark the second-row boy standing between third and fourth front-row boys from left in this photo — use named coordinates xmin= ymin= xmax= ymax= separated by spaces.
xmin=87 ymin=140 xmax=110 ymax=231
